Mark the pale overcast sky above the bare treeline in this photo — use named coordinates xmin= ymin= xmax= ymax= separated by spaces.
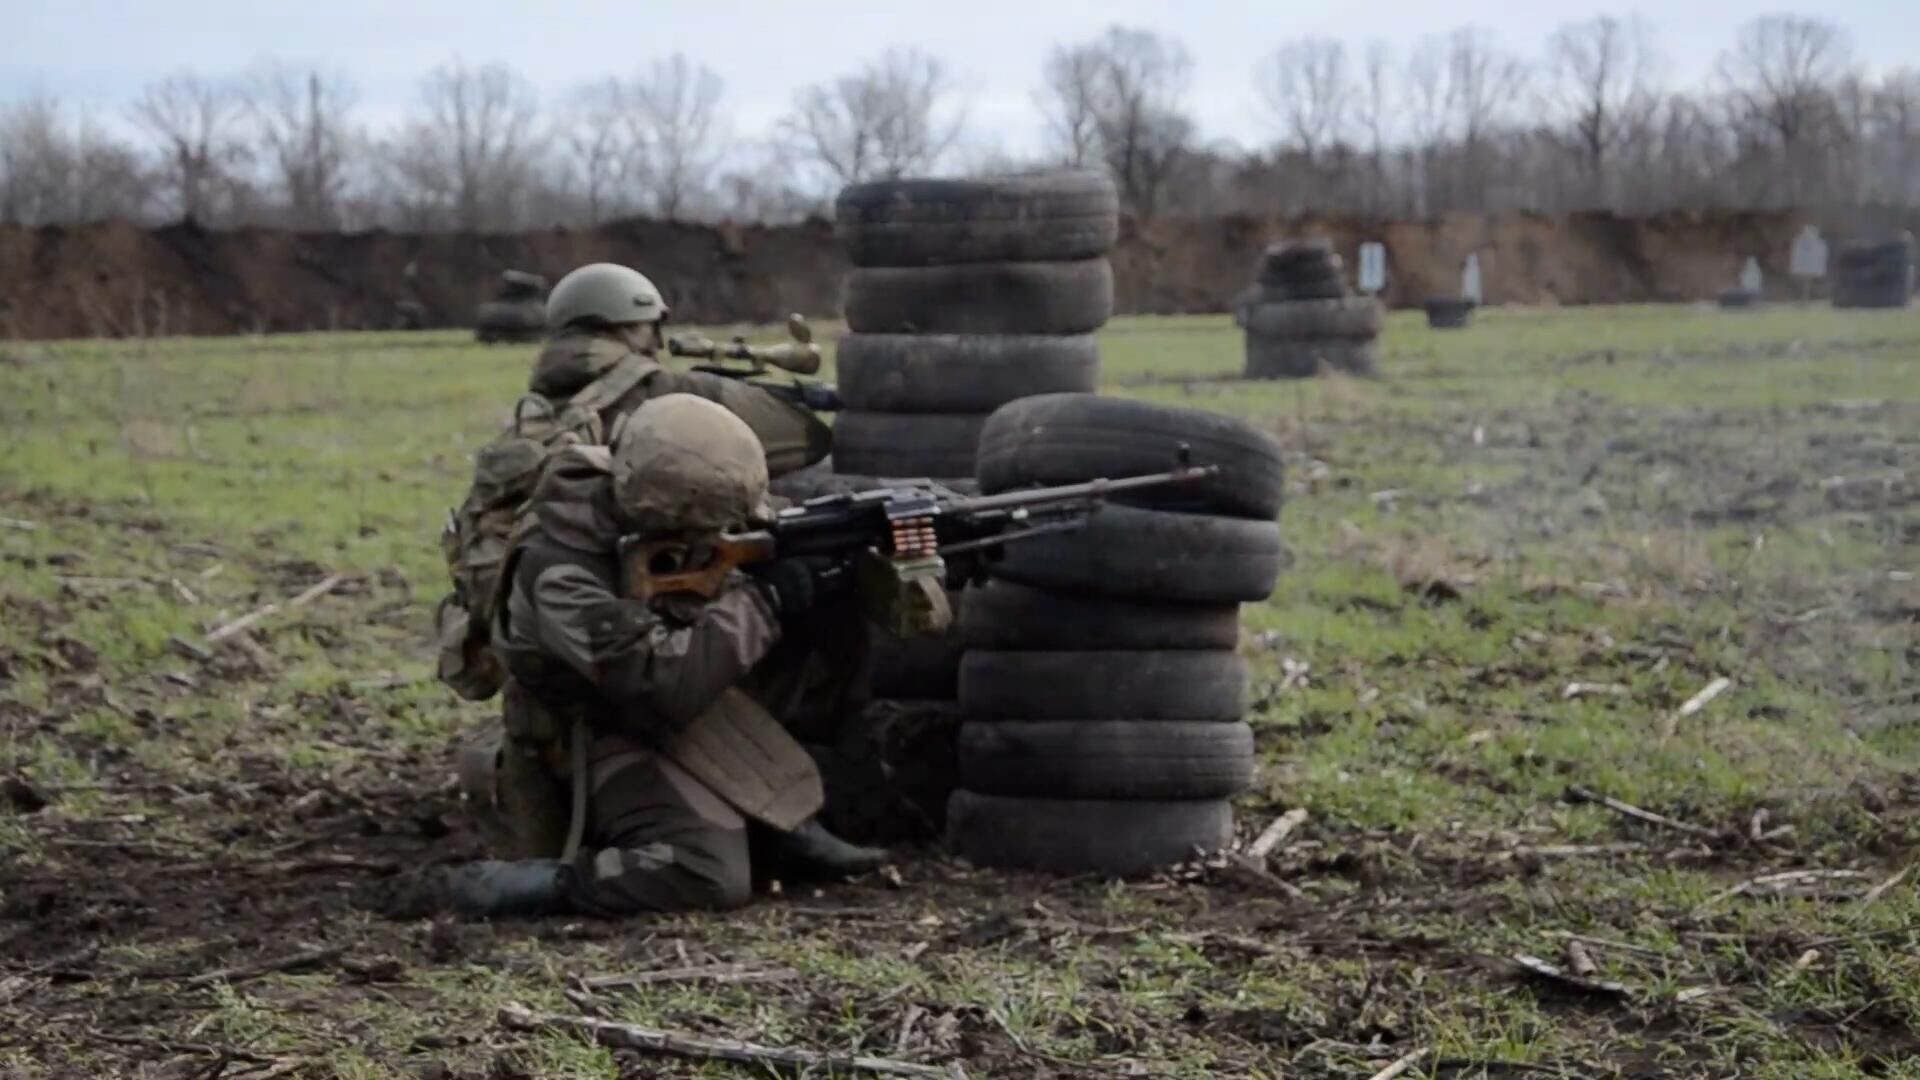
xmin=0 ymin=0 xmax=1920 ymax=154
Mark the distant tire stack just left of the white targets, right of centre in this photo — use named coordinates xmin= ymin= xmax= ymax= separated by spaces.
xmin=1236 ymin=240 xmax=1382 ymax=379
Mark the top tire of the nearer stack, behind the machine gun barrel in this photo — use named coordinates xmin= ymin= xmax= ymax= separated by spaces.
xmin=977 ymin=394 xmax=1284 ymax=521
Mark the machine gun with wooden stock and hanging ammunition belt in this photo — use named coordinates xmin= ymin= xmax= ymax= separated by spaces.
xmin=620 ymin=457 xmax=1219 ymax=638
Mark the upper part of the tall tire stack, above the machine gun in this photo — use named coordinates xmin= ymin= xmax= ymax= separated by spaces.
xmin=833 ymin=171 xmax=1119 ymax=479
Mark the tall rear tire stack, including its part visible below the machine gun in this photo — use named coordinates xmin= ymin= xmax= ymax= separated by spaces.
xmin=829 ymin=171 xmax=1119 ymax=842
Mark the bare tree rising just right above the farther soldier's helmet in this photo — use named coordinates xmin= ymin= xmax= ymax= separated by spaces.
xmin=632 ymin=52 xmax=722 ymax=221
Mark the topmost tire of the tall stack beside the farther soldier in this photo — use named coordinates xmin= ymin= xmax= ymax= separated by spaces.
xmin=833 ymin=171 xmax=1119 ymax=267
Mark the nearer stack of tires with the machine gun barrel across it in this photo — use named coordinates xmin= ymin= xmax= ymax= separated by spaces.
xmin=947 ymin=394 xmax=1284 ymax=876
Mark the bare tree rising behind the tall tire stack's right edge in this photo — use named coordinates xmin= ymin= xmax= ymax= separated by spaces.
xmin=1041 ymin=27 xmax=1194 ymax=217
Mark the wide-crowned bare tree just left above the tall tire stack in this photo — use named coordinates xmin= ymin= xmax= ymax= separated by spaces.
xmin=780 ymin=48 xmax=964 ymax=184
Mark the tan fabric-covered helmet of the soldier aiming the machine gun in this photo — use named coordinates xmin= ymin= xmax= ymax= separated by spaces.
xmin=612 ymin=394 xmax=772 ymax=536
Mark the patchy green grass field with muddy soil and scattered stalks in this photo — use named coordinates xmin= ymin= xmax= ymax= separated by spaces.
xmin=0 ymin=307 xmax=1920 ymax=1080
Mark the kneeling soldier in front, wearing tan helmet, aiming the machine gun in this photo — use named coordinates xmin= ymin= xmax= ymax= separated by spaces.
xmin=408 ymin=390 xmax=885 ymax=917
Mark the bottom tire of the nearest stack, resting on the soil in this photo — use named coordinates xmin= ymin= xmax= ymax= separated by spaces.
xmin=947 ymin=790 xmax=1233 ymax=876
